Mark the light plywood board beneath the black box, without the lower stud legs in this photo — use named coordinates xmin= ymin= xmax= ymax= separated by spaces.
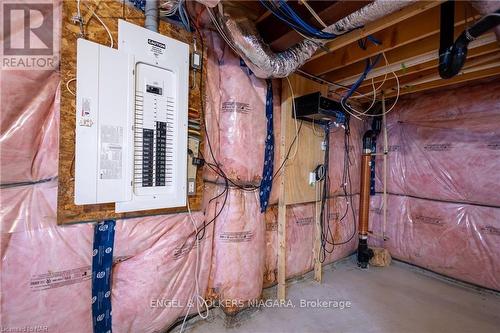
xmin=281 ymin=74 xmax=328 ymax=205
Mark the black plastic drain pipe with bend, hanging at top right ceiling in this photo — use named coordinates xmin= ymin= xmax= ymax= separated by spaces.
xmin=439 ymin=1 xmax=500 ymax=79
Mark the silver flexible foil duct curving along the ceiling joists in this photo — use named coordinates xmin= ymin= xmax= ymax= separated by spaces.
xmin=208 ymin=0 xmax=415 ymax=78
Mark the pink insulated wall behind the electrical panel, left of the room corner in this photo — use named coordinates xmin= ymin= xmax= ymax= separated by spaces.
xmin=0 ymin=6 xmax=357 ymax=332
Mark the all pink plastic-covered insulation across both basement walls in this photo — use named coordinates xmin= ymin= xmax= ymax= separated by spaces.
xmin=0 ymin=6 xmax=500 ymax=332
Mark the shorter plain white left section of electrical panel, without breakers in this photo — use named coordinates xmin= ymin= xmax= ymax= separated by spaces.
xmin=75 ymin=39 xmax=133 ymax=205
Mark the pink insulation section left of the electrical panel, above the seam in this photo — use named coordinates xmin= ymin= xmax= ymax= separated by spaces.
xmin=0 ymin=70 xmax=60 ymax=184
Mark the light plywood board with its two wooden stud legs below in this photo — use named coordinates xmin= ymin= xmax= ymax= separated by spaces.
xmin=277 ymin=74 xmax=328 ymax=300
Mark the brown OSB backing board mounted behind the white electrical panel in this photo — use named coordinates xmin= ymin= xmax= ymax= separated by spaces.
xmin=57 ymin=0 xmax=206 ymax=224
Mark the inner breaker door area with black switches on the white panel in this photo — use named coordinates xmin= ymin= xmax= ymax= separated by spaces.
xmin=134 ymin=64 xmax=177 ymax=195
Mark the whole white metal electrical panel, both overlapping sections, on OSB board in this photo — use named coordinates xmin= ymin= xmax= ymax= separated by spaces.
xmin=75 ymin=20 xmax=189 ymax=212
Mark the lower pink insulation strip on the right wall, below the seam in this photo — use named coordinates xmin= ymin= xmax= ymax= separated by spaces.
xmin=370 ymin=195 xmax=500 ymax=290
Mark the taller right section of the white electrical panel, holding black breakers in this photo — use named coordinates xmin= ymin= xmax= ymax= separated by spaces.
xmin=115 ymin=20 xmax=189 ymax=212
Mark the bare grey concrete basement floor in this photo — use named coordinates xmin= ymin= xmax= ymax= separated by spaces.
xmin=180 ymin=257 xmax=500 ymax=333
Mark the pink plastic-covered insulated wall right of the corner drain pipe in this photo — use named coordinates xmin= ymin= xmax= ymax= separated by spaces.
xmin=371 ymin=80 xmax=500 ymax=290
